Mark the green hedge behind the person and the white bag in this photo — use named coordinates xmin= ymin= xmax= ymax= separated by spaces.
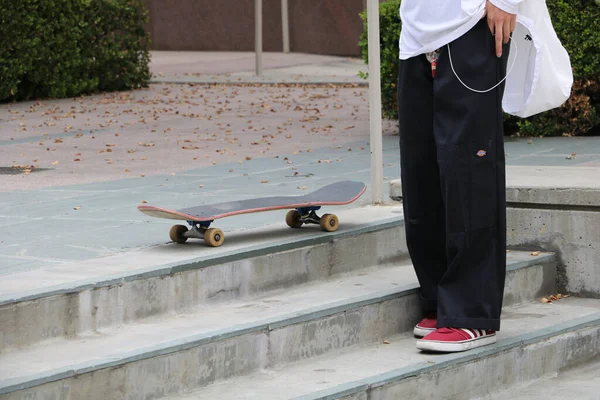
xmin=359 ymin=0 xmax=600 ymax=136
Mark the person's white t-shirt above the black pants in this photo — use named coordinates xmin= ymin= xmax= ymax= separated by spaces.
xmin=400 ymin=0 xmax=522 ymax=60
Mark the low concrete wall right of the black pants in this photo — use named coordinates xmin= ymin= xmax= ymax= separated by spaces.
xmin=506 ymin=188 xmax=600 ymax=298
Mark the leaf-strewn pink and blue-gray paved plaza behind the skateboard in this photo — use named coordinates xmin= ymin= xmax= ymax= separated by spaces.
xmin=0 ymin=54 xmax=600 ymax=294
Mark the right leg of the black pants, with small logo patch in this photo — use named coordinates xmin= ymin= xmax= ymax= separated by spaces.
xmin=433 ymin=19 xmax=509 ymax=333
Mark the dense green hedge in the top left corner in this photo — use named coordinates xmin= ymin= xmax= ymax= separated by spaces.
xmin=0 ymin=0 xmax=150 ymax=101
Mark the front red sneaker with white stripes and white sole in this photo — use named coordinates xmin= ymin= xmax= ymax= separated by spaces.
xmin=417 ymin=328 xmax=496 ymax=353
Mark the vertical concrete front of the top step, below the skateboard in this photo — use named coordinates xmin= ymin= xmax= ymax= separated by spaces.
xmin=0 ymin=218 xmax=408 ymax=354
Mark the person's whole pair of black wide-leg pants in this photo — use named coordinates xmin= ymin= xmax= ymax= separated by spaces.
xmin=398 ymin=19 xmax=509 ymax=330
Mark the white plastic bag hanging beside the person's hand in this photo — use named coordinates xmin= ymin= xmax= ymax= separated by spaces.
xmin=502 ymin=0 xmax=573 ymax=118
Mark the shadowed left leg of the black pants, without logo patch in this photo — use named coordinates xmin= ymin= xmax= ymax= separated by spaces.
xmin=398 ymin=55 xmax=447 ymax=314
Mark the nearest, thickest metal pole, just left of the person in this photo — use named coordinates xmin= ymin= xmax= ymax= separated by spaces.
xmin=367 ymin=0 xmax=383 ymax=204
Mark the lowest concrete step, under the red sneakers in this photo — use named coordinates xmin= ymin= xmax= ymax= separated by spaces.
xmin=169 ymin=298 xmax=600 ymax=400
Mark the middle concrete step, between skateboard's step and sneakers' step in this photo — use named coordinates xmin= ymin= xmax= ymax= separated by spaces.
xmin=0 ymin=252 xmax=555 ymax=399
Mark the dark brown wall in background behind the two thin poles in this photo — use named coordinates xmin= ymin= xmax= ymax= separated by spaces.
xmin=146 ymin=0 xmax=366 ymax=56
